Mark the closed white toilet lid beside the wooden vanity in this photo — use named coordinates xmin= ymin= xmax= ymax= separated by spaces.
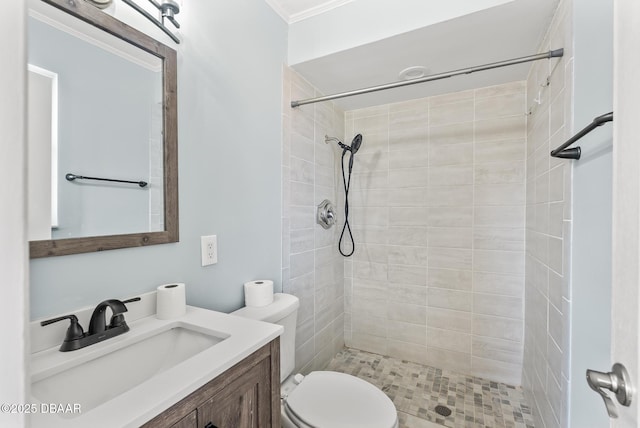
xmin=284 ymin=371 xmax=397 ymax=428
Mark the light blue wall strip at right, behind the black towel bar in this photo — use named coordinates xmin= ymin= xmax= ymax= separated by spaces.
xmin=570 ymin=0 xmax=613 ymax=428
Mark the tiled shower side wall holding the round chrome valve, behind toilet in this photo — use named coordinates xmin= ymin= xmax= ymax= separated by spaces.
xmin=282 ymin=66 xmax=344 ymax=373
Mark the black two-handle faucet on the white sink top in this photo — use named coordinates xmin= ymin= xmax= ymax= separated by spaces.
xmin=40 ymin=297 xmax=140 ymax=352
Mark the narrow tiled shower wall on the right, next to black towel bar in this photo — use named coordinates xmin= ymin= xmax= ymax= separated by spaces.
xmin=522 ymin=1 xmax=573 ymax=428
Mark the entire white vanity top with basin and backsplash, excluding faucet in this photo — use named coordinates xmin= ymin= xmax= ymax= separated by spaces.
xmin=30 ymin=300 xmax=282 ymax=428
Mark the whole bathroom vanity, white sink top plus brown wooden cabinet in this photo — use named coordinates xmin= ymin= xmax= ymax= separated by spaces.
xmin=30 ymin=291 xmax=283 ymax=428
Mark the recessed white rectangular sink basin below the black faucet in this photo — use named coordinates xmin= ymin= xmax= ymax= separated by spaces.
xmin=31 ymin=324 xmax=228 ymax=418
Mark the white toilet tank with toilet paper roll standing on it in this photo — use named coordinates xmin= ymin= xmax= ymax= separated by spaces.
xmin=231 ymin=293 xmax=300 ymax=382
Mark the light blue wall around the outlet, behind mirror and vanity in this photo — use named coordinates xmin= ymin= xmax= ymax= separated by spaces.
xmin=30 ymin=0 xmax=287 ymax=319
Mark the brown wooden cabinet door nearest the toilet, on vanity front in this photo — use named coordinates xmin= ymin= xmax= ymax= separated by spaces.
xmin=198 ymin=359 xmax=271 ymax=428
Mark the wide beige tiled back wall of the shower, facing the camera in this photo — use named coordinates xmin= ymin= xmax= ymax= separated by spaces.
xmin=340 ymin=81 xmax=527 ymax=384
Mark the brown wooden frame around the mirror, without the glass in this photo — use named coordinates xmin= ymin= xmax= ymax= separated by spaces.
xmin=29 ymin=0 xmax=179 ymax=259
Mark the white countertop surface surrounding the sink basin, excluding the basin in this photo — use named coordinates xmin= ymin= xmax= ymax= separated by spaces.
xmin=31 ymin=306 xmax=283 ymax=428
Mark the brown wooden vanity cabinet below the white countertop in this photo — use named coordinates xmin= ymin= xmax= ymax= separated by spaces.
xmin=143 ymin=337 xmax=280 ymax=428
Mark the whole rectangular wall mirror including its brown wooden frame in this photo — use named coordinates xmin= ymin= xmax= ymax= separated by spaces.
xmin=28 ymin=0 xmax=178 ymax=258
